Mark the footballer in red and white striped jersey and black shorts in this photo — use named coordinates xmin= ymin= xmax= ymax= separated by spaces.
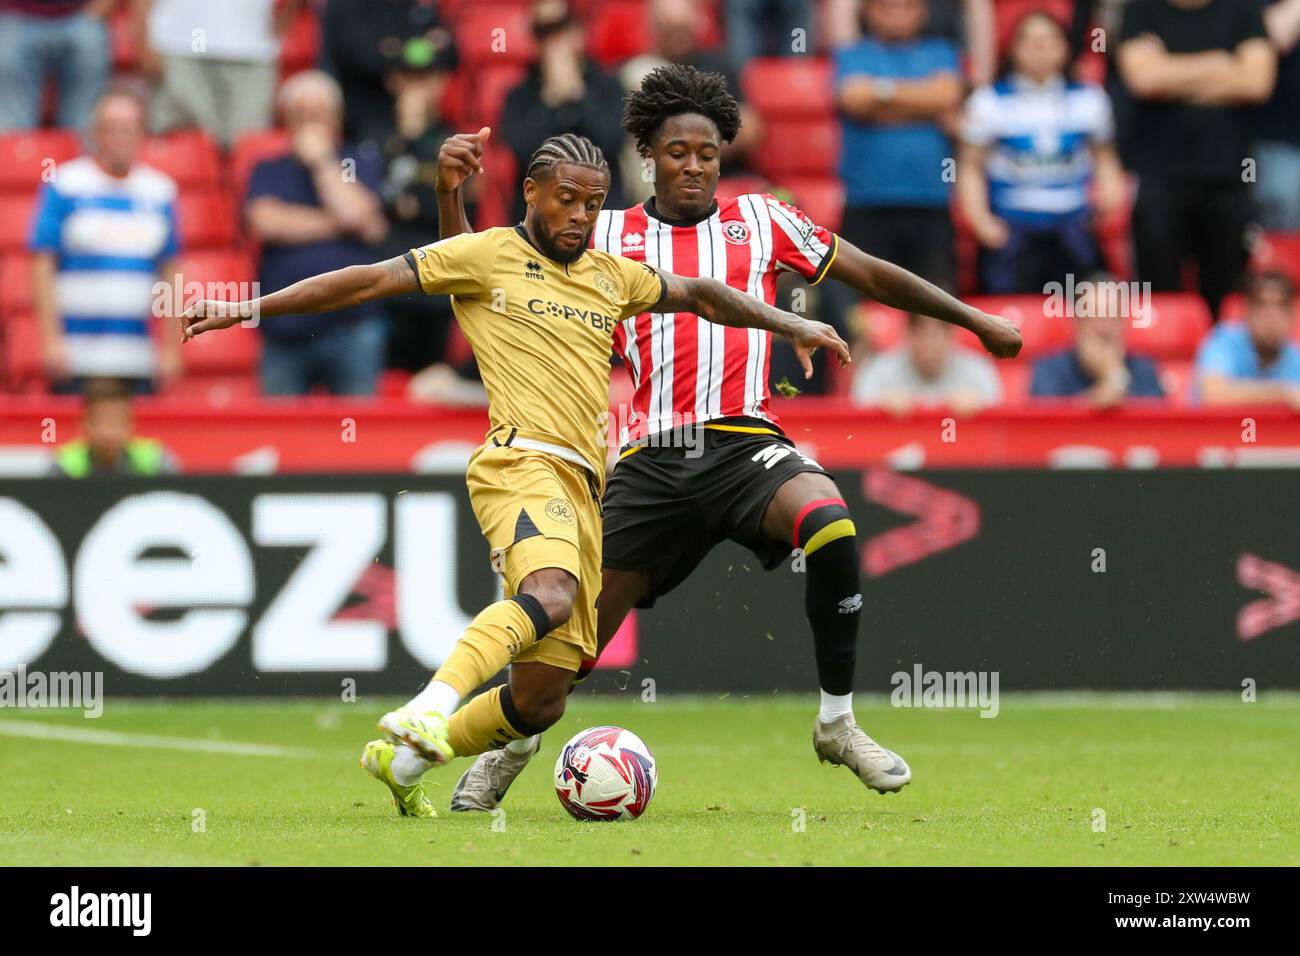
xmin=439 ymin=65 xmax=1021 ymax=810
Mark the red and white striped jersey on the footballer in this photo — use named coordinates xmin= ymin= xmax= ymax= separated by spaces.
xmin=592 ymin=193 xmax=837 ymax=440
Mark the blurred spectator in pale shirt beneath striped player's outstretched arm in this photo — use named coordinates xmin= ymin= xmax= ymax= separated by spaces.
xmin=852 ymin=315 xmax=1002 ymax=415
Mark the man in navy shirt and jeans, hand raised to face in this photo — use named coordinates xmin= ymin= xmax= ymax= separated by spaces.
xmin=244 ymin=70 xmax=389 ymax=395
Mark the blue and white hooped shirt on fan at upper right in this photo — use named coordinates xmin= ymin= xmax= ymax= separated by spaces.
xmin=962 ymin=74 xmax=1114 ymax=225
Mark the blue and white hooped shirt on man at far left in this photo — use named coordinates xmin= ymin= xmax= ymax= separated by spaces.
xmin=30 ymin=156 xmax=179 ymax=378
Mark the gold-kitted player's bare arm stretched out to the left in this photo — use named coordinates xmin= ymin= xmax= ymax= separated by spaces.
xmin=181 ymin=256 xmax=420 ymax=341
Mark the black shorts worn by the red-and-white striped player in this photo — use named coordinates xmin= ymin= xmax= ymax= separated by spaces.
xmin=602 ymin=419 xmax=827 ymax=607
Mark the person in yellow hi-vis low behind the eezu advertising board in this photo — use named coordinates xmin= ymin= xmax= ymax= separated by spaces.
xmin=51 ymin=378 xmax=179 ymax=477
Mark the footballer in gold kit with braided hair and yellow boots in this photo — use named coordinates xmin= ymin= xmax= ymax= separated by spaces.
xmin=182 ymin=131 xmax=849 ymax=817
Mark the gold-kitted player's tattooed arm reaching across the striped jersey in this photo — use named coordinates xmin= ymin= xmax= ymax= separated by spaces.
xmin=650 ymin=271 xmax=853 ymax=378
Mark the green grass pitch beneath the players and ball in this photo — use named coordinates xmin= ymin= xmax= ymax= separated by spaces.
xmin=0 ymin=692 xmax=1300 ymax=866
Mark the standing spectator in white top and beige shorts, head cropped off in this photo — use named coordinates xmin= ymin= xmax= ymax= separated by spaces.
xmin=131 ymin=0 xmax=303 ymax=150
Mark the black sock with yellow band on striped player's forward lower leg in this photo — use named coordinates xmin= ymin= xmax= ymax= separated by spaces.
xmin=794 ymin=498 xmax=862 ymax=722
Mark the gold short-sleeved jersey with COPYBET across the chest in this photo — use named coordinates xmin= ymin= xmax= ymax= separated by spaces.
xmin=407 ymin=226 xmax=664 ymax=480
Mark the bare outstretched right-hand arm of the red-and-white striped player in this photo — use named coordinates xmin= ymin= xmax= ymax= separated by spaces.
xmin=828 ymin=237 xmax=1021 ymax=359
